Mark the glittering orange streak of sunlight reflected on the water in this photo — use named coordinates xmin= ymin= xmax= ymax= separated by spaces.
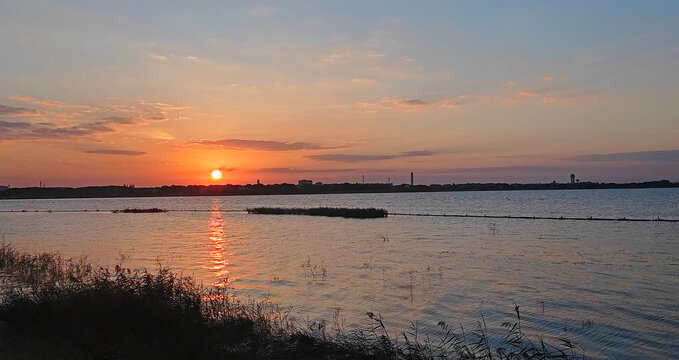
xmin=205 ymin=200 xmax=230 ymax=287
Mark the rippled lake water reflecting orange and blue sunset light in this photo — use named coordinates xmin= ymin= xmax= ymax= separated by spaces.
xmin=0 ymin=189 xmax=679 ymax=358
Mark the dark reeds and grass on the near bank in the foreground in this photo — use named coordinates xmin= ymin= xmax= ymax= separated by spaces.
xmin=0 ymin=245 xmax=583 ymax=359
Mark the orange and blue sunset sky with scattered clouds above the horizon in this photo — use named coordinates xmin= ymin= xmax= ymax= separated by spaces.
xmin=0 ymin=0 xmax=679 ymax=187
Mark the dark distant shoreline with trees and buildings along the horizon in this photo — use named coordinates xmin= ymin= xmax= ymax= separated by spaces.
xmin=0 ymin=180 xmax=679 ymax=200
